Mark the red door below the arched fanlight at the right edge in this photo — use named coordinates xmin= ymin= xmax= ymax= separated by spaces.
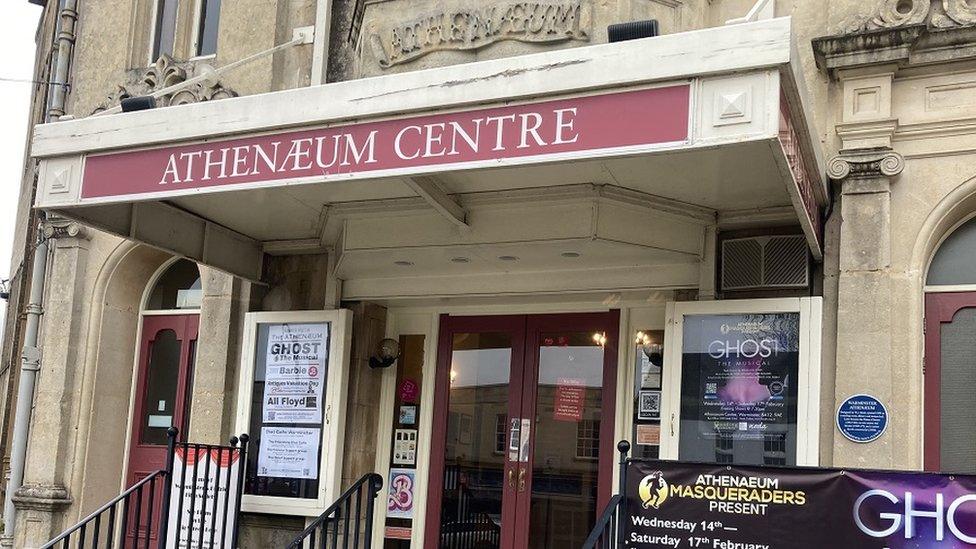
xmin=924 ymin=292 xmax=976 ymax=473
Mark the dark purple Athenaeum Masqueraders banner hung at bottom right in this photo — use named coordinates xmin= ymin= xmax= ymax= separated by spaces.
xmin=622 ymin=461 xmax=976 ymax=549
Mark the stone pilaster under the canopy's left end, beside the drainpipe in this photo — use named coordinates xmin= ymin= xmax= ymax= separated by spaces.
xmin=13 ymin=219 xmax=90 ymax=547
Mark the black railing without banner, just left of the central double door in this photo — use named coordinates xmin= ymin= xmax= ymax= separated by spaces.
xmin=287 ymin=473 xmax=383 ymax=549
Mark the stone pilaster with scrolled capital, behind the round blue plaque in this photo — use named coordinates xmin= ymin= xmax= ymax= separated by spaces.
xmin=827 ymin=148 xmax=905 ymax=468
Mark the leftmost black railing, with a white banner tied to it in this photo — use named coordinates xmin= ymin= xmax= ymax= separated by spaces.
xmin=41 ymin=428 xmax=247 ymax=549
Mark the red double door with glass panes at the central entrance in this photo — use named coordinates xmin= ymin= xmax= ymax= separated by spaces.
xmin=425 ymin=311 xmax=619 ymax=549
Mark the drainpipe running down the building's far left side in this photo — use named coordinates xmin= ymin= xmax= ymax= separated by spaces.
xmin=3 ymin=0 xmax=78 ymax=545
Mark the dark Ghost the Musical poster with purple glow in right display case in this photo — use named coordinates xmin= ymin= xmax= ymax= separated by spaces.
xmin=679 ymin=313 xmax=800 ymax=465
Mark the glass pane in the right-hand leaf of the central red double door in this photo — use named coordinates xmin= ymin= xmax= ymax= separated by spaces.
xmin=520 ymin=332 xmax=605 ymax=549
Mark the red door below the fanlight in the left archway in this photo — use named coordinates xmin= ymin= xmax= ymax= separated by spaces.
xmin=126 ymin=314 xmax=199 ymax=540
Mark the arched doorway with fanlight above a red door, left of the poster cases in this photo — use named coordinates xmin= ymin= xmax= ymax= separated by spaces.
xmin=126 ymin=259 xmax=203 ymax=535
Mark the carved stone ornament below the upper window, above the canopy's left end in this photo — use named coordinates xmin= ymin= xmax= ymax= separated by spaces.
xmin=93 ymin=54 xmax=237 ymax=113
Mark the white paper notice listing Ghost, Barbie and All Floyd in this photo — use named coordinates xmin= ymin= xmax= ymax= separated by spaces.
xmin=263 ymin=324 xmax=329 ymax=425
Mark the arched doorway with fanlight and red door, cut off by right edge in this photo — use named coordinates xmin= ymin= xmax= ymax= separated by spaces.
xmin=924 ymin=217 xmax=976 ymax=473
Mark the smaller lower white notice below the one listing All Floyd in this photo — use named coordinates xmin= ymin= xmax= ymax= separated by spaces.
xmin=258 ymin=426 xmax=322 ymax=479
